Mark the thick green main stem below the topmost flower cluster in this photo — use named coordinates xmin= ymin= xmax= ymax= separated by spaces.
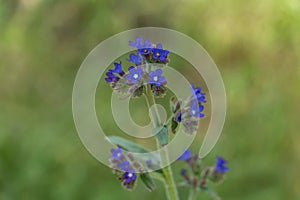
xmin=145 ymin=85 xmax=179 ymax=200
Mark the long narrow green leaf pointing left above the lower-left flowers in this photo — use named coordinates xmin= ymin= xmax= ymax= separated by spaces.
xmin=107 ymin=136 xmax=151 ymax=153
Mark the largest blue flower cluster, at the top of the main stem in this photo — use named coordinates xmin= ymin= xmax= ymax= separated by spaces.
xmin=105 ymin=38 xmax=169 ymax=97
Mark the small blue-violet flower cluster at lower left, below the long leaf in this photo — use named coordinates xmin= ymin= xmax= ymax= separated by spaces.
xmin=109 ymin=146 xmax=137 ymax=190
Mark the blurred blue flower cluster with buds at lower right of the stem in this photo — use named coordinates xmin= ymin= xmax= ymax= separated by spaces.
xmin=178 ymin=150 xmax=229 ymax=190
